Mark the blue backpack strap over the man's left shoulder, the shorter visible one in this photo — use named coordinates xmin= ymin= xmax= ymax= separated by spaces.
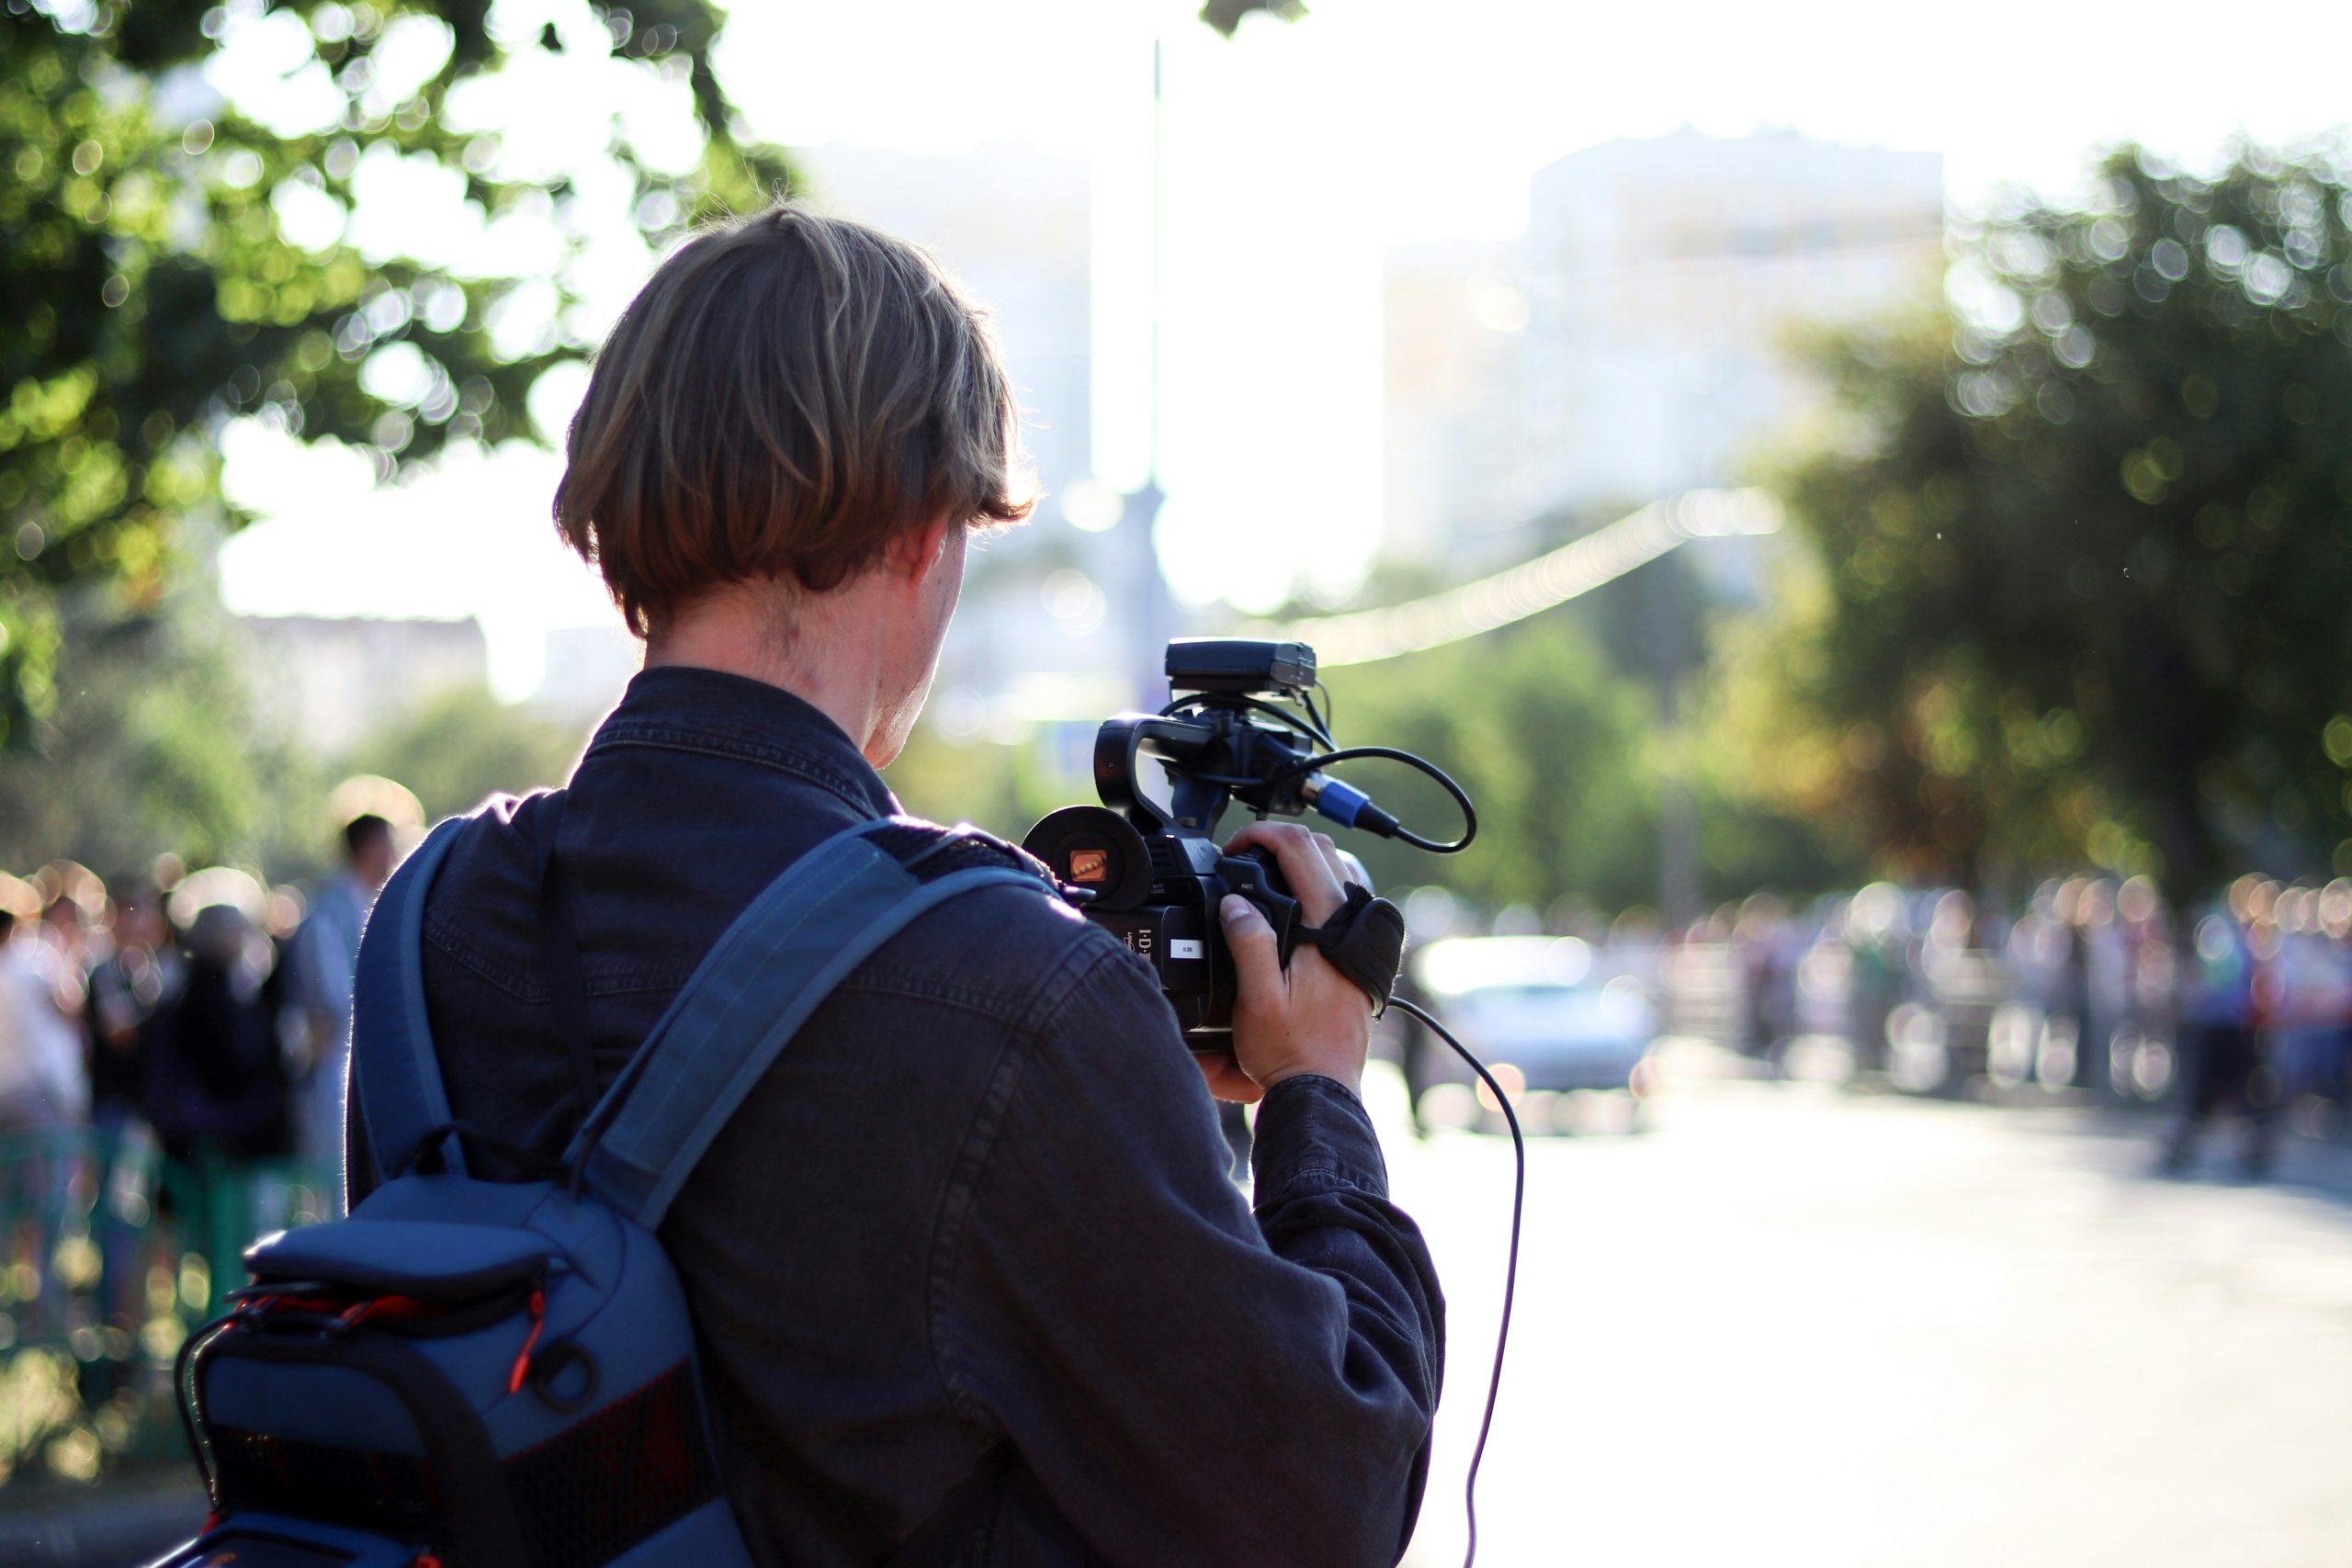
xmin=350 ymin=816 xmax=473 ymax=1180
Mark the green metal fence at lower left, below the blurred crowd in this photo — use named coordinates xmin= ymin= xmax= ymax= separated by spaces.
xmin=0 ymin=1128 xmax=336 ymax=1488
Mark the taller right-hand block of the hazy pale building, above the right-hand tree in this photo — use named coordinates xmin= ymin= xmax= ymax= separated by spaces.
xmin=1521 ymin=131 xmax=1945 ymax=505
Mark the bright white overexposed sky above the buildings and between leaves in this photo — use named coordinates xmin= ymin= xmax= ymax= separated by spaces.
xmin=217 ymin=0 xmax=2345 ymax=696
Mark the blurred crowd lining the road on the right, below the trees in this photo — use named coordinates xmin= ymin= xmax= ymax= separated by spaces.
xmin=1681 ymin=874 xmax=2352 ymax=1170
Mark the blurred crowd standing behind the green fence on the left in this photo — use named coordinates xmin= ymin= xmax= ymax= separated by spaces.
xmin=0 ymin=816 xmax=398 ymax=1164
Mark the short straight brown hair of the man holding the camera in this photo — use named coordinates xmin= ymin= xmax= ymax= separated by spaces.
xmin=555 ymin=202 xmax=1035 ymax=637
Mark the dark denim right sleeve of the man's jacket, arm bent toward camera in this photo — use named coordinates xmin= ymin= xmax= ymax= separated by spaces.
xmin=933 ymin=942 xmax=1444 ymax=1568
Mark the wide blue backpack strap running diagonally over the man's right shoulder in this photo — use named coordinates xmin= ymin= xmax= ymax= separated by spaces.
xmin=564 ymin=818 xmax=1051 ymax=1229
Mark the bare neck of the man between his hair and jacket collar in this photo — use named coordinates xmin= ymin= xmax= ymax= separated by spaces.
xmin=644 ymin=583 xmax=882 ymax=750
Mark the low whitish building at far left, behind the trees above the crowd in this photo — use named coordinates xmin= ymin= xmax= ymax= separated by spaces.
xmin=238 ymin=616 xmax=489 ymax=757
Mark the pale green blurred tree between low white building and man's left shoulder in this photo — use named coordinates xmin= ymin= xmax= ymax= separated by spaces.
xmin=341 ymin=686 xmax=588 ymax=823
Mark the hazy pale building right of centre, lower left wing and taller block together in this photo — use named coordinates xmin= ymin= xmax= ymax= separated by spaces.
xmin=1383 ymin=131 xmax=1945 ymax=564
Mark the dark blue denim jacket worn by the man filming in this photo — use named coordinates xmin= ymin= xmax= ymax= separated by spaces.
xmin=350 ymin=668 xmax=1444 ymax=1568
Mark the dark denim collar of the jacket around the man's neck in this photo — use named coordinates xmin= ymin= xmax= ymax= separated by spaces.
xmin=585 ymin=665 xmax=899 ymax=816
